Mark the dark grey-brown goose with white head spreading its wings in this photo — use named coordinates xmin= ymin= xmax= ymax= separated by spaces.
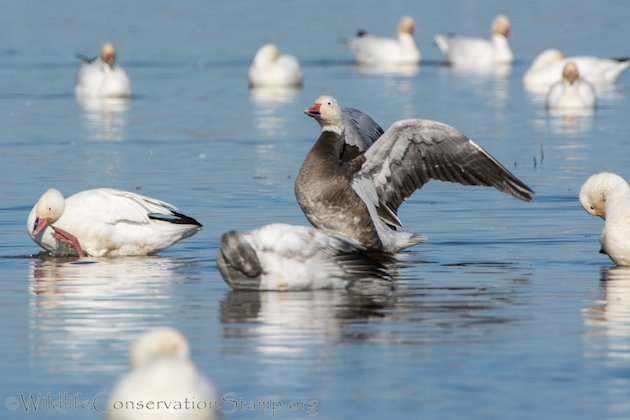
xmin=295 ymin=96 xmax=534 ymax=252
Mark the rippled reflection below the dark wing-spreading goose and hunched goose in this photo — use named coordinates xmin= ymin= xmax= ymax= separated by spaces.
xmin=221 ymin=263 xmax=529 ymax=352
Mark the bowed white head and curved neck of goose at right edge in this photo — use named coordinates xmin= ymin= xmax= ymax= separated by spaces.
xmin=580 ymin=172 xmax=630 ymax=219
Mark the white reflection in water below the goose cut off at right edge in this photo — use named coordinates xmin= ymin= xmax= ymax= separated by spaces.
xmin=584 ymin=267 xmax=630 ymax=360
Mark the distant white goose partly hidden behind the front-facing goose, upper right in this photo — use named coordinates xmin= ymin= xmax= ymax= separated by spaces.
xmin=523 ymin=49 xmax=630 ymax=88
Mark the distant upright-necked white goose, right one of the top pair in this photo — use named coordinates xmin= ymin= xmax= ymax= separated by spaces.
xmin=434 ymin=15 xmax=514 ymax=67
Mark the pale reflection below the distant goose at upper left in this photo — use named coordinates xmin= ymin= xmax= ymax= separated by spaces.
xmin=77 ymin=97 xmax=129 ymax=141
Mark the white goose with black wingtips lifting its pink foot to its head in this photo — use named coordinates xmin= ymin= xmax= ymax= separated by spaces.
xmin=27 ymin=188 xmax=201 ymax=257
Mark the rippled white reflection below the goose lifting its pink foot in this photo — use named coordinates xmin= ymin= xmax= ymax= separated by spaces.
xmin=29 ymin=257 xmax=188 ymax=376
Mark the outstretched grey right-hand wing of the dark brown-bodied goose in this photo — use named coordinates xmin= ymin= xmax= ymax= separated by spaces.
xmin=354 ymin=120 xmax=534 ymax=212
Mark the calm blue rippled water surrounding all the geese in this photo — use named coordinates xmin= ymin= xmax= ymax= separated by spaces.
xmin=0 ymin=0 xmax=630 ymax=419
